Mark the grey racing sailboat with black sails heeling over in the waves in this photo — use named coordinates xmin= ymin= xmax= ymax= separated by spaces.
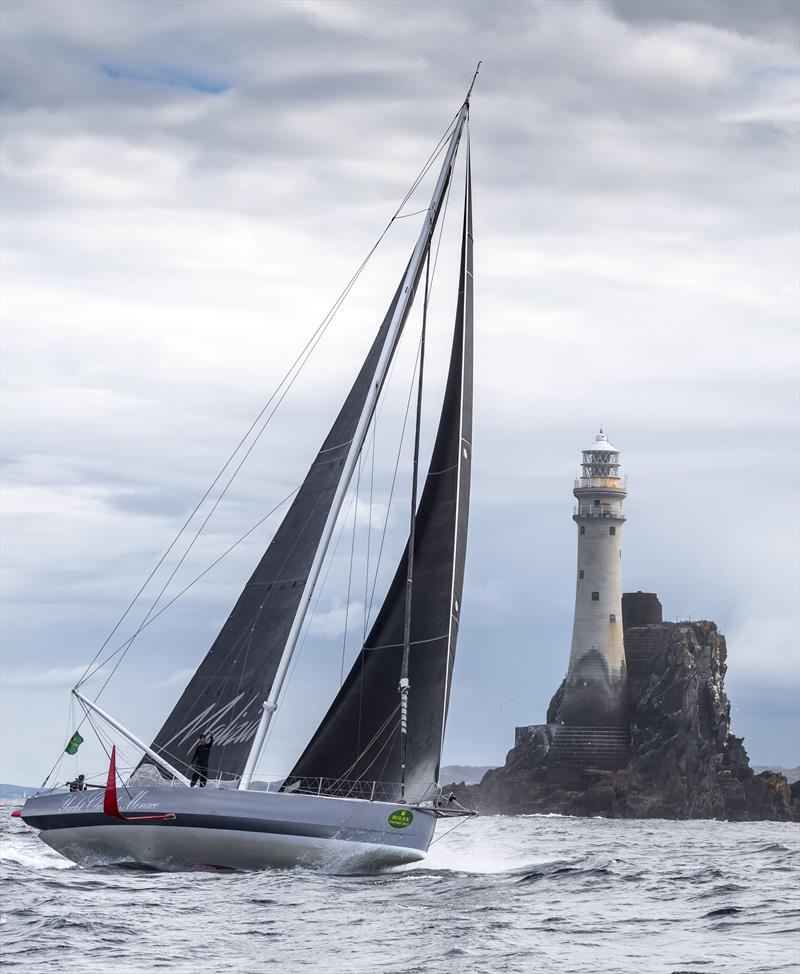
xmin=19 ymin=71 xmax=477 ymax=869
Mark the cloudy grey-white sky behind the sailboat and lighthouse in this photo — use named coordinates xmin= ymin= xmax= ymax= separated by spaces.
xmin=0 ymin=0 xmax=800 ymax=784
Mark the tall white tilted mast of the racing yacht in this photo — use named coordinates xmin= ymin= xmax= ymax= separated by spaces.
xmin=239 ymin=99 xmax=469 ymax=790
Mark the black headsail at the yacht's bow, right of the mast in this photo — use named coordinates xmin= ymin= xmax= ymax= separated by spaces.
xmin=284 ymin=149 xmax=473 ymax=801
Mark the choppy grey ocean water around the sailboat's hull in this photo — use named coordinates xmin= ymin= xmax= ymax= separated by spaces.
xmin=0 ymin=802 xmax=800 ymax=974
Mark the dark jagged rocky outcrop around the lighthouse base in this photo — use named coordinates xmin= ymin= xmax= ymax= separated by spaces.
xmin=449 ymin=622 xmax=800 ymax=821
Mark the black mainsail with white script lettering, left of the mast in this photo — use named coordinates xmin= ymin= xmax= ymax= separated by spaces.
xmin=144 ymin=130 xmax=466 ymax=778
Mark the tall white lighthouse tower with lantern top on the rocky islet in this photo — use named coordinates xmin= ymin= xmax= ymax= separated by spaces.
xmin=550 ymin=429 xmax=629 ymax=768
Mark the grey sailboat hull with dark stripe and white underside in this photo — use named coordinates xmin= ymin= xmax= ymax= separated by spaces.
xmin=22 ymin=787 xmax=436 ymax=870
